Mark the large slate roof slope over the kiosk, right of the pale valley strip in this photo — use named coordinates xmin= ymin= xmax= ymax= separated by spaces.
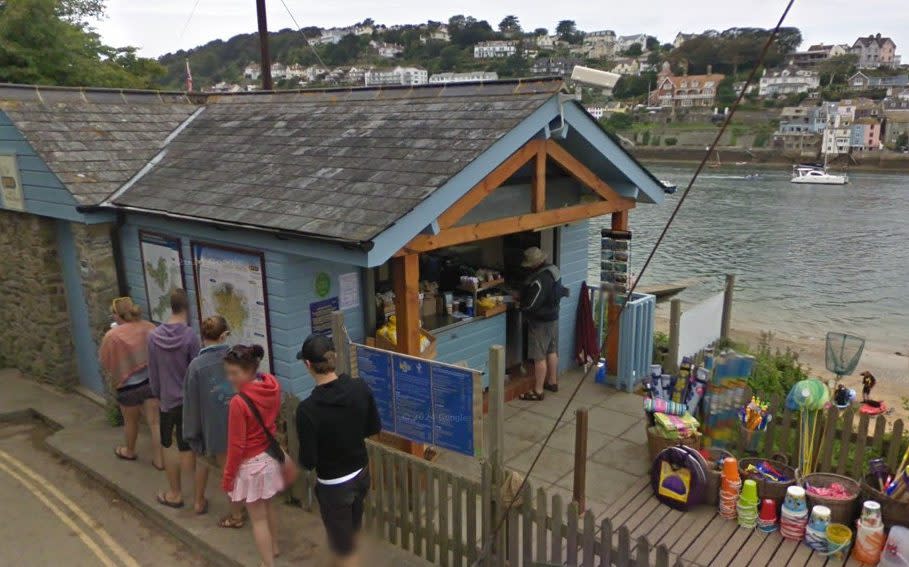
xmin=111 ymin=79 xmax=562 ymax=241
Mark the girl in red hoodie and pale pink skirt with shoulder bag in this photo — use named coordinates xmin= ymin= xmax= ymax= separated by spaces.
xmin=221 ymin=345 xmax=284 ymax=567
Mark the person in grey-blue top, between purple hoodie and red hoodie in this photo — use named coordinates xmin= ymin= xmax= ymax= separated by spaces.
xmin=183 ymin=315 xmax=246 ymax=528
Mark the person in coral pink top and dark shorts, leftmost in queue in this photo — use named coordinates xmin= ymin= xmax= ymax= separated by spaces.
xmin=98 ymin=297 xmax=164 ymax=470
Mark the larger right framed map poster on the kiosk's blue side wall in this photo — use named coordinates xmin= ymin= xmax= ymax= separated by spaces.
xmin=191 ymin=242 xmax=273 ymax=371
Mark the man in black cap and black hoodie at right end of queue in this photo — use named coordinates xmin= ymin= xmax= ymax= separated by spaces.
xmin=296 ymin=335 xmax=382 ymax=567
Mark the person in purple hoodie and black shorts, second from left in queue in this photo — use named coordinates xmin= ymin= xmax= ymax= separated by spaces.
xmin=148 ymin=289 xmax=208 ymax=514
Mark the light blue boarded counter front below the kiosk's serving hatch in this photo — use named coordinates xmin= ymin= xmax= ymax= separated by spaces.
xmin=433 ymin=313 xmax=506 ymax=388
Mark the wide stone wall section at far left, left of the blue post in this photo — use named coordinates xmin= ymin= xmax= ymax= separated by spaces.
xmin=0 ymin=210 xmax=76 ymax=387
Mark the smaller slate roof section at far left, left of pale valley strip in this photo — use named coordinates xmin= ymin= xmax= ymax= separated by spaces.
xmin=0 ymin=85 xmax=198 ymax=205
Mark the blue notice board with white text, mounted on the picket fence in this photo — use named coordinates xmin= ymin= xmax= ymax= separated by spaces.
xmin=356 ymin=345 xmax=483 ymax=456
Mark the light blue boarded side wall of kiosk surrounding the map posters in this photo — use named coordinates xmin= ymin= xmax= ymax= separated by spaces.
xmin=121 ymin=215 xmax=364 ymax=397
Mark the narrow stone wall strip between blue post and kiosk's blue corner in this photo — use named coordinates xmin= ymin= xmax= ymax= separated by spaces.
xmin=72 ymin=223 xmax=119 ymax=352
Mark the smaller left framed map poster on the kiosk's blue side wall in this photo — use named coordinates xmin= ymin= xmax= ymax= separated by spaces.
xmin=139 ymin=230 xmax=186 ymax=323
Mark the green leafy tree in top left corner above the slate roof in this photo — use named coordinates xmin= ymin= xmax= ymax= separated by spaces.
xmin=0 ymin=0 xmax=162 ymax=88
